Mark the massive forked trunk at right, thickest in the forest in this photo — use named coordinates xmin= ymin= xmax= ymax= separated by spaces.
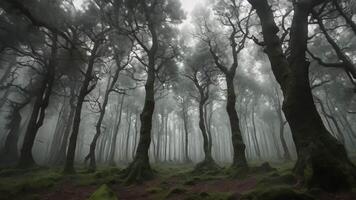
xmin=249 ymin=0 xmax=356 ymax=191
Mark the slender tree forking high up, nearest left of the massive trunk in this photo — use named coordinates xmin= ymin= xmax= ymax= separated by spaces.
xmin=195 ymin=0 xmax=251 ymax=168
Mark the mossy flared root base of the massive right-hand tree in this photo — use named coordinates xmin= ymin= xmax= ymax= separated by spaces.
xmin=294 ymin=138 xmax=356 ymax=192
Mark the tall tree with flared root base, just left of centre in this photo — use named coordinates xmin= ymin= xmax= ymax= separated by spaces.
xmin=121 ymin=0 xmax=183 ymax=182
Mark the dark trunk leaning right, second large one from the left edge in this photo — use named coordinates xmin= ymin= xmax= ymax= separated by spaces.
xmin=18 ymin=35 xmax=57 ymax=168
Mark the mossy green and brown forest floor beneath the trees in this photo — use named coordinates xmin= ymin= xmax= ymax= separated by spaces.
xmin=0 ymin=163 xmax=356 ymax=200
